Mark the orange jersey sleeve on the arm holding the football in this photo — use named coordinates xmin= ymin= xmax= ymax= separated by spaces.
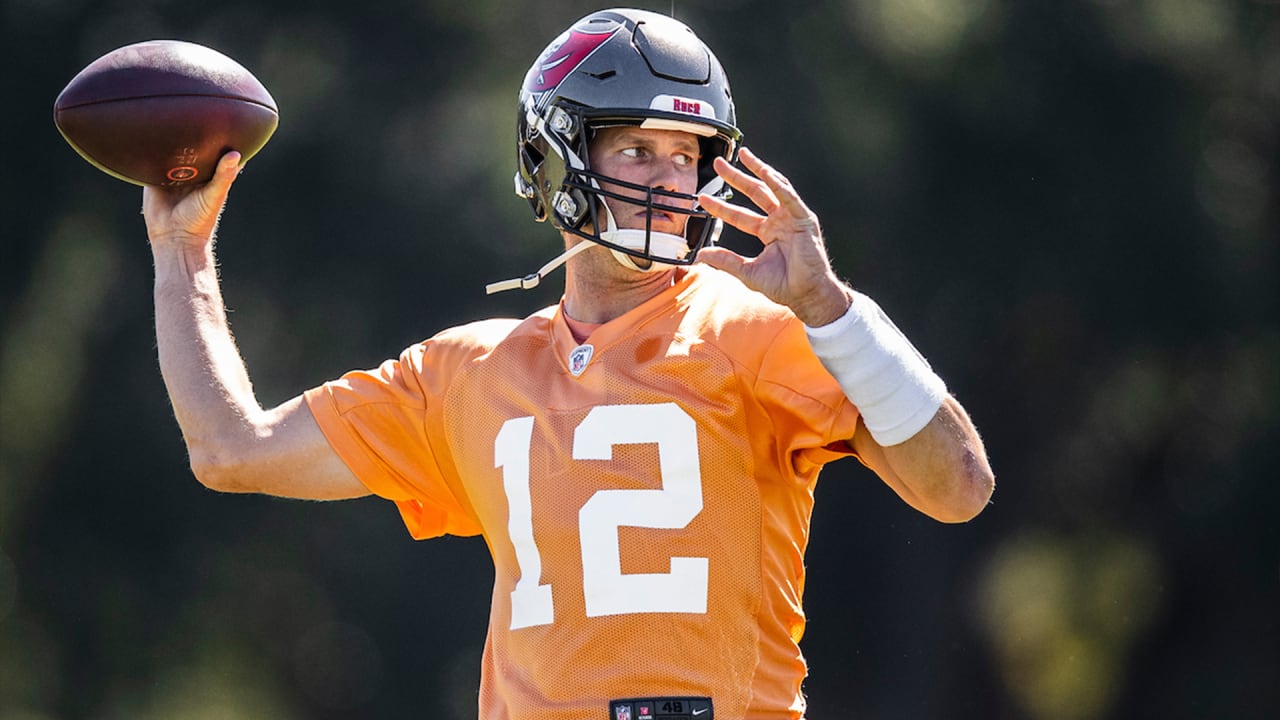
xmin=303 ymin=343 xmax=480 ymax=539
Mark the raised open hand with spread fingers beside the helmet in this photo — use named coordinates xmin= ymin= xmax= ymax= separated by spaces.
xmin=698 ymin=147 xmax=851 ymax=327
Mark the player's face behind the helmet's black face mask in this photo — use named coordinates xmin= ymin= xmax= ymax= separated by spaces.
xmin=590 ymin=127 xmax=700 ymax=234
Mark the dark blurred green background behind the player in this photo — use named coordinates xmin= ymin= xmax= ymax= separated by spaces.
xmin=0 ymin=0 xmax=1280 ymax=720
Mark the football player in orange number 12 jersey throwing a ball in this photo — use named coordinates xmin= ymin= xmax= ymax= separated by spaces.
xmin=143 ymin=9 xmax=993 ymax=720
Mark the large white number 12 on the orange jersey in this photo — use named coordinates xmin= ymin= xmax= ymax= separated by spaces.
xmin=494 ymin=402 xmax=708 ymax=630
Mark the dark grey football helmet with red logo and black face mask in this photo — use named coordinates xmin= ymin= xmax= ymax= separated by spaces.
xmin=515 ymin=9 xmax=741 ymax=275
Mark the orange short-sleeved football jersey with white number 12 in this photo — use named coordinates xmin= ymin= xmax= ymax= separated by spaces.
xmin=306 ymin=266 xmax=858 ymax=720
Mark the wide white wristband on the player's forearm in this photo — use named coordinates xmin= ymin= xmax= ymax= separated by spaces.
xmin=805 ymin=292 xmax=947 ymax=446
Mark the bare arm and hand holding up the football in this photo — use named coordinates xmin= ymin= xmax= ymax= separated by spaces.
xmin=142 ymin=151 xmax=369 ymax=500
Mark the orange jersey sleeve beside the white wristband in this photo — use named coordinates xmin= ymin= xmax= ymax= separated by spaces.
xmin=756 ymin=313 xmax=858 ymax=475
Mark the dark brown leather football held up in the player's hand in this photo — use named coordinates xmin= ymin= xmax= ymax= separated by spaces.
xmin=54 ymin=40 xmax=280 ymax=187
